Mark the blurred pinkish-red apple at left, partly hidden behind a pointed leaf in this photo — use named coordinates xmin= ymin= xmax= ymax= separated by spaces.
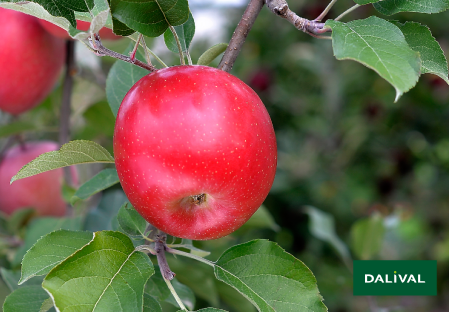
xmin=0 ymin=141 xmax=77 ymax=216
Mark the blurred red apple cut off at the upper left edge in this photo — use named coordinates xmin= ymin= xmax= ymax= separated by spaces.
xmin=0 ymin=8 xmax=65 ymax=115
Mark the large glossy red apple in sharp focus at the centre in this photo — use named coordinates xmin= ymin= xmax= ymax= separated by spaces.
xmin=113 ymin=66 xmax=277 ymax=240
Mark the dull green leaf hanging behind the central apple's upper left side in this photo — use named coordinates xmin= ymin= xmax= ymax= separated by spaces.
xmin=106 ymin=44 xmax=149 ymax=116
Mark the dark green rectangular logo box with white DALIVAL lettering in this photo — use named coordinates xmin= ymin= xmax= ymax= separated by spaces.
xmin=353 ymin=260 xmax=437 ymax=296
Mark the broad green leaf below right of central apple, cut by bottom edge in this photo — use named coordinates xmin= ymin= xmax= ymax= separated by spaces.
xmin=215 ymin=240 xmax=327 ymax=312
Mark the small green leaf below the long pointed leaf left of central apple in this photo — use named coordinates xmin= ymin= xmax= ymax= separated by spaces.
xmin=70 ymin=169 xmax=120 ymax=205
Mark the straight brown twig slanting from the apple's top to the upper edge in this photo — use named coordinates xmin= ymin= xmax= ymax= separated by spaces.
xmin=218 ymin=0 xmax=265 ymax=73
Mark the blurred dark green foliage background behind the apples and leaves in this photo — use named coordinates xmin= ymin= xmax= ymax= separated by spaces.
xmin=0 ymin=0 xmax=449 ymax=312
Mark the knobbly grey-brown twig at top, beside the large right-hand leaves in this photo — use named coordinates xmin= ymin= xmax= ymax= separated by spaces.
xmin=266 ymin=0 xmax=332 ymax=39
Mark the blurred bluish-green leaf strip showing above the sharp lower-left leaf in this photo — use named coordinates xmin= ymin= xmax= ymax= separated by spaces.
xmin=12 ymin=217 xmax=81 ymax=266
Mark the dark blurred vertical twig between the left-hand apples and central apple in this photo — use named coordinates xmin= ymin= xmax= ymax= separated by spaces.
xmin=59 ymin=40 xmax=76 ymax=186
